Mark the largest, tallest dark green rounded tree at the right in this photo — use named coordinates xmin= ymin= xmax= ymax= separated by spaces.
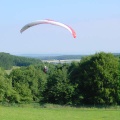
xmin=79 ymin=52 xmax=120 ymax=105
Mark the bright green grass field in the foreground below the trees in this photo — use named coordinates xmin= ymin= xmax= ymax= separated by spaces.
xmin=0 ymin=106 xmax=120 ymax=120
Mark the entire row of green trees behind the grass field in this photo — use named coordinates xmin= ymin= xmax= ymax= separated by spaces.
xmin=0 ymin=52 xmax=120 ymax=105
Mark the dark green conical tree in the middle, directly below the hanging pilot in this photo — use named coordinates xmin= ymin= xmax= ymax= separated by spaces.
xmin=44 ymin=65 xmax=74 ymax=104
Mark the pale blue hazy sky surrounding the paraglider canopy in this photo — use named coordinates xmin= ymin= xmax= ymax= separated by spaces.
xmin=0 ymin=0 xmax=120 ymax=54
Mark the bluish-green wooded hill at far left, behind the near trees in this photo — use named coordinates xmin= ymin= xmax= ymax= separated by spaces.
xmin=0 ymin=52 xmax=41 ymax=69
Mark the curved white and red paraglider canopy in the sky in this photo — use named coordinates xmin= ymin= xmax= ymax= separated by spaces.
xmin=20 ymin=19 xmax=76 ymax=38
